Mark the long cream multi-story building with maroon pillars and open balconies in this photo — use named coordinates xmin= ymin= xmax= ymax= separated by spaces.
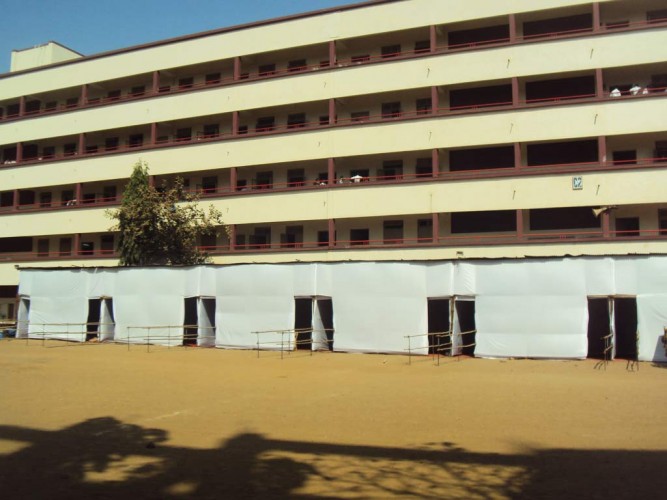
xmin=0 ymin=0 xmax=667 ymax=360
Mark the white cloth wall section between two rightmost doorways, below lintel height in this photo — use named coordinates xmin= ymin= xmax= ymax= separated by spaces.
xmin=475 ymin=295 xmax=587 ymax=358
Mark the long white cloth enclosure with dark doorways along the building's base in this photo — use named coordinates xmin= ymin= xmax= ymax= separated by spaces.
xmin=18 ymin=256 xmax=667 ymax=361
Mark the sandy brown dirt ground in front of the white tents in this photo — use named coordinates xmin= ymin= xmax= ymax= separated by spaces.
xmin=0 ymin=340 xmax=667 ymax=499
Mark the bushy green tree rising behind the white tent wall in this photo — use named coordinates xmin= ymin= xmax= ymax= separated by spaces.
xmin=107 ymin=161 xmax=225 ymax=266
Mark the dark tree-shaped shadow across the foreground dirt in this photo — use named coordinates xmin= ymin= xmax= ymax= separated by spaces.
xmin=0 ymin=417 xmax=667 ymax=499
